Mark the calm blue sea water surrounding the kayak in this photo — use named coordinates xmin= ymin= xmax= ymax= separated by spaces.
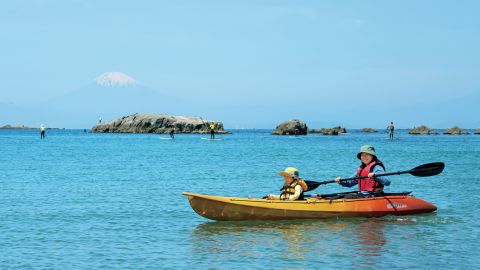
xmin=0 ymin=130 xmax=480 ymax=269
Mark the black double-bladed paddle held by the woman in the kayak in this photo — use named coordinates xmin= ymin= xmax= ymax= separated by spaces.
xmin=304 ymin=162 xmax=445 ymax=191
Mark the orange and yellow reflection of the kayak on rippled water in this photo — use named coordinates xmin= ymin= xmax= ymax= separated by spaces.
xmin=190 ymin=219 xmax=415 ymax=267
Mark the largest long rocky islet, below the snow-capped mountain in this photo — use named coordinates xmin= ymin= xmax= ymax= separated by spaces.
xmin=90 ymin=114 xmax=232 ymax=134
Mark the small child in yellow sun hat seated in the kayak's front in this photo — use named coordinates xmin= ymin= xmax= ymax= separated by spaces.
xmin=267 ymin=167 xmax=308 ymax=201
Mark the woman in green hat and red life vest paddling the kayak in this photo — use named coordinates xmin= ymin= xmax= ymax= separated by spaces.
xmin=335 ymin=145 xmax=391 ymax=194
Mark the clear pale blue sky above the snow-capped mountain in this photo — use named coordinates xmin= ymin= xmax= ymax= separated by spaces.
xmin=0 ymin=0 xmax=480 ymax=117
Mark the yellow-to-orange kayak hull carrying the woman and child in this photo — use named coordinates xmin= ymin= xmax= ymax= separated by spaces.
xmin=182 ymin=192 xmax=437 ymax=221
